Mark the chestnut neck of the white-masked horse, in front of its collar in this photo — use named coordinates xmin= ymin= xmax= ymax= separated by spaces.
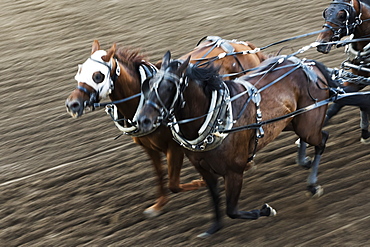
xmin=110 ymin=63 xmax=141 ymax=119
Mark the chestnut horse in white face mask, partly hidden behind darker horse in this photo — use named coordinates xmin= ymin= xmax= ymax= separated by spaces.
xmin=66 ymin=37 xmax=265 ymax=216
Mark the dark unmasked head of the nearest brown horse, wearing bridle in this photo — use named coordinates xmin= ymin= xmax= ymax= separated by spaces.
xmin=138 ymin=51 xmax=190 ymax=131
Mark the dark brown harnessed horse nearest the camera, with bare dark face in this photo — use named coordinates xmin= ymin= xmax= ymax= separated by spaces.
xmin=138 ymin=52 xmax=331 ymax=237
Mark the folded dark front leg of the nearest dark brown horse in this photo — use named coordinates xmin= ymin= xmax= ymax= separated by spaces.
xmin=225 ymin=171 xmax=276 ymax=220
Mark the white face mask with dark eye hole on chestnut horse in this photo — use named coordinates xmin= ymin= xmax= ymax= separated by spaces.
xmin=75 ymin=50 xmax=113 ymax=100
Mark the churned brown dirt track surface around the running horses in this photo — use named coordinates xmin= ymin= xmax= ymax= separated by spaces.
xmin=0 ymin=0 xmax=370 ymax=247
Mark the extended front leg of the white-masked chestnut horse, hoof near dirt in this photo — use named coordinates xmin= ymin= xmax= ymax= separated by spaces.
xmin=144 ymin=147 xmax=169 ymax=217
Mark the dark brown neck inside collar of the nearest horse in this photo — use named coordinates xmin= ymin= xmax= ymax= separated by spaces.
xmin=175 ymin=80 xmax=211 ymax=139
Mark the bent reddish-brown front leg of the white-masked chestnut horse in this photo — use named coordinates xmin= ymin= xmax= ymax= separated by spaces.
xmin=166 ymin=142 xmax=206 ymax=193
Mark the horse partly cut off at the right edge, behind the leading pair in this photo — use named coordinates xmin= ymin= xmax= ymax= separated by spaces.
xmin=316 ymin=0 xmax=370 ymax=143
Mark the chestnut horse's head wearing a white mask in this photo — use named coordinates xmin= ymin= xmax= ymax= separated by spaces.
xmin=66 ymin=40 xmax=119 ymax=118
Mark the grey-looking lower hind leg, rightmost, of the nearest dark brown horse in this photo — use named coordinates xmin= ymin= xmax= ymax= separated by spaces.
xmin=307 ymin=131 xmax=329 ymax=197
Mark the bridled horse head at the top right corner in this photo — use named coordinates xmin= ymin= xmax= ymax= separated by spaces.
xmin=316 ymin=0 xmax=362 ymax=54
